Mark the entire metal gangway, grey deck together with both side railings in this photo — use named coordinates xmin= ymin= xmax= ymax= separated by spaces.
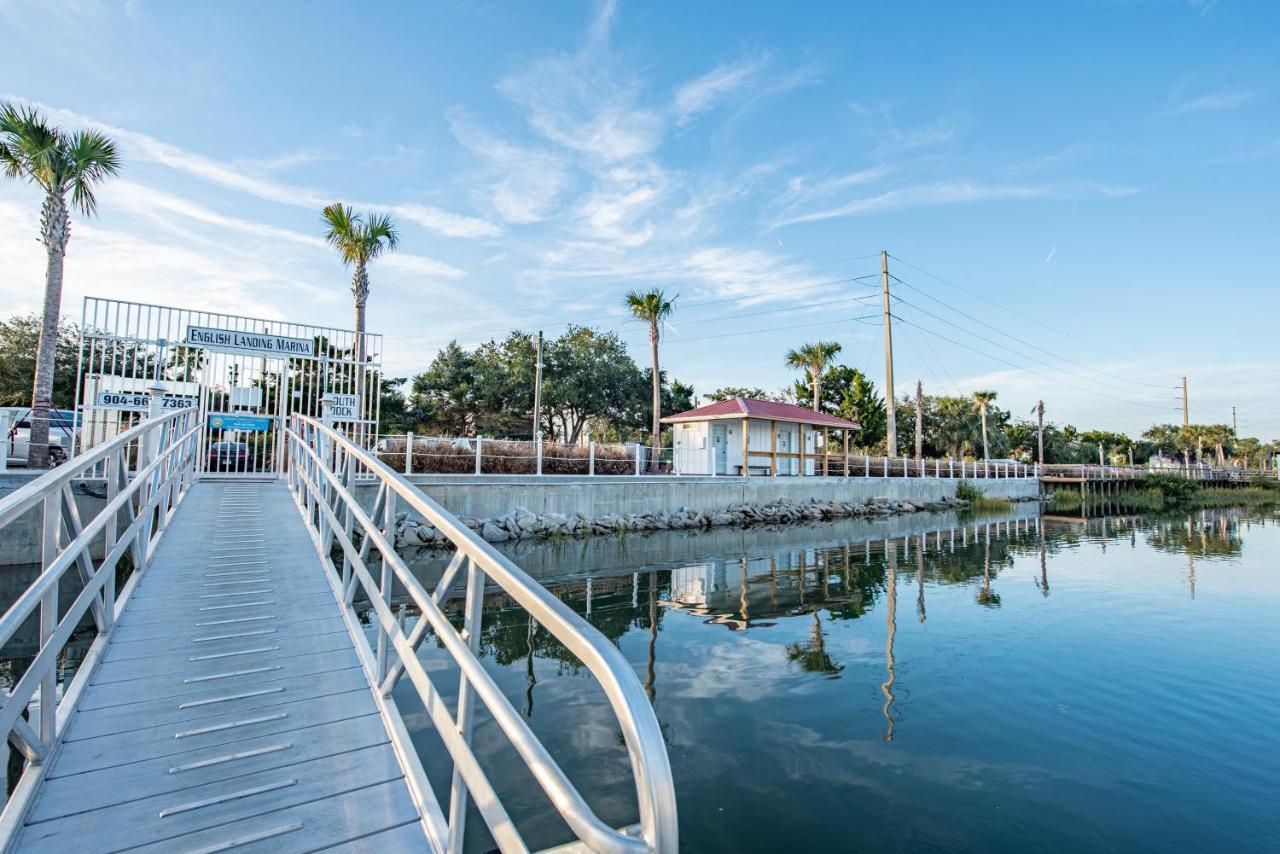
xmin=0 ymin=408 xmax=678 ymax=854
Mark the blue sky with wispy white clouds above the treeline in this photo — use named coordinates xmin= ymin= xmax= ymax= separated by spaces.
xmin=0 ymin=0 xmax=1280 ymax=439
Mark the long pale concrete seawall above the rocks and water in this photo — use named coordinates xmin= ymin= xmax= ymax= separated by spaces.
xmin=391 ymin=475 xmax=1039 ymax=519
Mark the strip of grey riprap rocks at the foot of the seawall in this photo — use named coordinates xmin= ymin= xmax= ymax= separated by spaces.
xmin=396 ymin=498 xmax=969 ymax=547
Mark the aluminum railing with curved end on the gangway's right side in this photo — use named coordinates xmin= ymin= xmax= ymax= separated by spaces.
xmin=287 ymin=415 xmax=678 ymax=853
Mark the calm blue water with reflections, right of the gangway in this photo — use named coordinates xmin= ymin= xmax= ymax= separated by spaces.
xmin=398 ymin=511 xmax=1280 ymax=851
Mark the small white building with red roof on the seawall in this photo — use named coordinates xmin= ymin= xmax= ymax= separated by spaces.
xmin=662 ymin=397 xmax=859 ymax=476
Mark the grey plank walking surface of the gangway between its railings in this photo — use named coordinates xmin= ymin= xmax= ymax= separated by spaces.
xmin=14 ymin=480 xmax=426 ymax=853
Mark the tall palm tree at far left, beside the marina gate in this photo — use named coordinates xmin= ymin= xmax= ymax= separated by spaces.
xmin=0 ymin=101 xmax=120 ymax=469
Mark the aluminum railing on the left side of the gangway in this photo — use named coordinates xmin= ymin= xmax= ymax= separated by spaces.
xmin=0 ymin=408 xmax=200 ymax=845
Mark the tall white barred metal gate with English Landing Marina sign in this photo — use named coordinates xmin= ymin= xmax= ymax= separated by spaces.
xmin=72 ymin=297 xmax=383 ymax=478
